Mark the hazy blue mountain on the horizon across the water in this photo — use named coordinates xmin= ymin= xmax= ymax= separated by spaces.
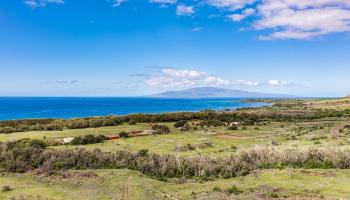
xmin=151 ymin=87 xmax=291 ymax=98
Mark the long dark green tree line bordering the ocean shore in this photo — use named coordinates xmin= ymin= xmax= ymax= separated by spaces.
xmin=0 ymin=107 xmax=350 ymax=133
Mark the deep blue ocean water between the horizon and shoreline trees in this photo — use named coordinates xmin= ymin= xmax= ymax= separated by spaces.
xmin=0 ymin=97 xmax=269 ymax=120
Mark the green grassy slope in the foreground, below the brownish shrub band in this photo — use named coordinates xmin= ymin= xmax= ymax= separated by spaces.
xmin=0 ymin=169 xmax=350 ymax=200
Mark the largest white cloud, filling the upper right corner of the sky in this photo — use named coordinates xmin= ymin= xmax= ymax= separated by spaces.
xmin=255 ymin=0 xmax=350 ymax=40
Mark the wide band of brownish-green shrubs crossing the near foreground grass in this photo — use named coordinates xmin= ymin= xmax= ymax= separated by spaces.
xmin=0 ymin=141 xmax=350 ymax=179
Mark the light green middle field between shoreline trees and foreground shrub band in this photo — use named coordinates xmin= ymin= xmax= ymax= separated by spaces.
xmin=0 ymin=119 xmax=350 ymax=156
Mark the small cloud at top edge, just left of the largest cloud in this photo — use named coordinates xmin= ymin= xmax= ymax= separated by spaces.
xmin=205 ymin=0 xmax=256 ymax=10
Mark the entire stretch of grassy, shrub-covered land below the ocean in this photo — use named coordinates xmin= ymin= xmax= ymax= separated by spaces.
xmin=0 ymin=99 xmax=350 ymax=199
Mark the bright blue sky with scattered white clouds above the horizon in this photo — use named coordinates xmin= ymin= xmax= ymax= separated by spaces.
xmin=0 ymin=0 xmax=350 ymax=97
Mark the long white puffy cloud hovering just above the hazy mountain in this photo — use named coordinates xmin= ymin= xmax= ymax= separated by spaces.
xmin=145 ymin=68 xmax=259 ymax=88
